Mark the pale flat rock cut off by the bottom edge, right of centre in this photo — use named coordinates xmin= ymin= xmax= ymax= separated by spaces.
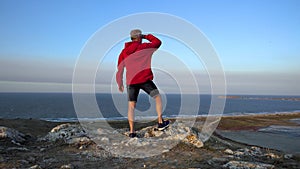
xmin=223 ymin=161 xmax=275 ymax=169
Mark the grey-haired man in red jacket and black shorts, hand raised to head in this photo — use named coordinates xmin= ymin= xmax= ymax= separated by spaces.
xmin=116 ymin=29 xmax=170 ymax=138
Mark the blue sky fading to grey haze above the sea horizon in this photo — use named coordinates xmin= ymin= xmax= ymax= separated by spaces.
xmin=0 ymin=0 xmax=300 ymax=95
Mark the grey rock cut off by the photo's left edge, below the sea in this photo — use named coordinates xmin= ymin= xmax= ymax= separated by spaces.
xmin=0 ymin=126 xmax=26 ymax=145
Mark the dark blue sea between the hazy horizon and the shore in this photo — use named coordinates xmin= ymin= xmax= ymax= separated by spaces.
xmin=0 ymin=93 xmax=300 ymax=122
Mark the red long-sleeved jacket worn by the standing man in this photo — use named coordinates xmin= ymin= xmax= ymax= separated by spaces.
xmin=116 ymin=34 xmax=161 ymax=86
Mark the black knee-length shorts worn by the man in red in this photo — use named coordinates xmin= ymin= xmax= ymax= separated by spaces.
xmin=127 ymin=80 xmax=159 ymax=102
